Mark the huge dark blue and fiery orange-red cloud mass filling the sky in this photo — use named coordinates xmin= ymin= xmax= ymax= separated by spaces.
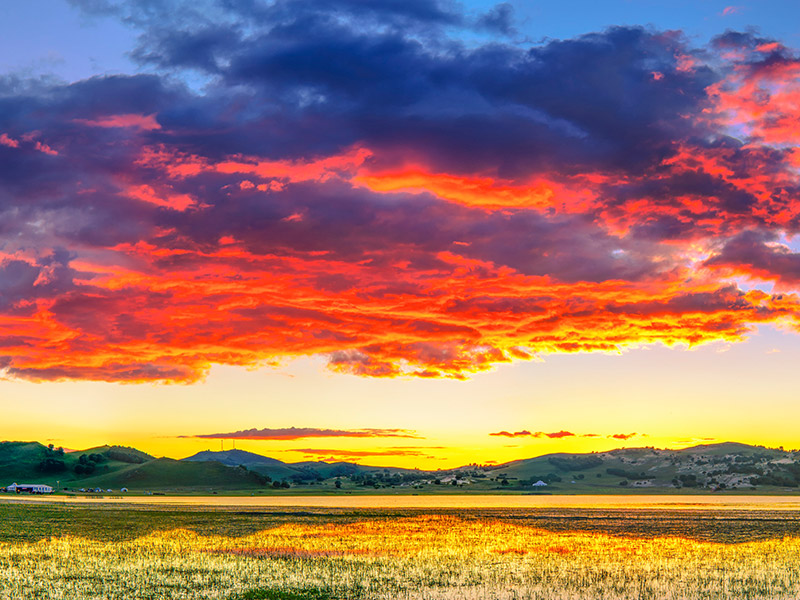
xmin=0 ymin=0 xmax=800 ymax=382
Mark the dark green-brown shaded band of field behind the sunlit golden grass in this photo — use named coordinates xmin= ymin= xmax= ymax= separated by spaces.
xmin=0 ymin=502 xmax=800 ymax=548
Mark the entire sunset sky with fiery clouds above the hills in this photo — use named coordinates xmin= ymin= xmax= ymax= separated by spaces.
xmin=0 ymin=0 xmax=800 ymax=468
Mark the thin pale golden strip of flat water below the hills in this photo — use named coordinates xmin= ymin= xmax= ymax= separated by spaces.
xmin=0 ymin=494 xmax=800 ymax=511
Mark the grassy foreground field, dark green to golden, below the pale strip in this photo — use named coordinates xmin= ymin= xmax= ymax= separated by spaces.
xmin=0 ymin=505 xmax=800 ymax=600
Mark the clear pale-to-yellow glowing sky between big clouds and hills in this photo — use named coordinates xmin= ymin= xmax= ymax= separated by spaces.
xmin=0 ymin=328 xmax=800 ymax=469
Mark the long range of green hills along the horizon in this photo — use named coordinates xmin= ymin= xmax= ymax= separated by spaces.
xmin=0 ymin=442 xmax=800 ymax=494
